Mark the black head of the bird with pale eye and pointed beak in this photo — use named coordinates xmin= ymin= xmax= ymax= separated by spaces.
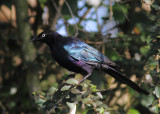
xmin=30 ymin=30 xmax=61 ymax=44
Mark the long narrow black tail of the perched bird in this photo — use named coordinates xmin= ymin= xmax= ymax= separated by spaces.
xmin=102 ymin=65 xmax=150 ymax=95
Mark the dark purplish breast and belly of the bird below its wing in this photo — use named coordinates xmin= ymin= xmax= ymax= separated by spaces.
xmin=48 ymin=41 xmax=93 ymax=74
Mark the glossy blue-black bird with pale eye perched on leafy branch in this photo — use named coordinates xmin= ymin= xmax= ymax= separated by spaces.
xmin=31 ymin=30 xmax=149 ymax=95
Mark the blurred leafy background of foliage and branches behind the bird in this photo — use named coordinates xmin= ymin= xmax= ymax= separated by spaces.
xmin=0 ymin=0 xmax=160 ymax=114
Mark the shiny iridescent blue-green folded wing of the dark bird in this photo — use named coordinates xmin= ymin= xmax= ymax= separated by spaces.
xmin=64 ymin=38 xmax=116 ymax=66
